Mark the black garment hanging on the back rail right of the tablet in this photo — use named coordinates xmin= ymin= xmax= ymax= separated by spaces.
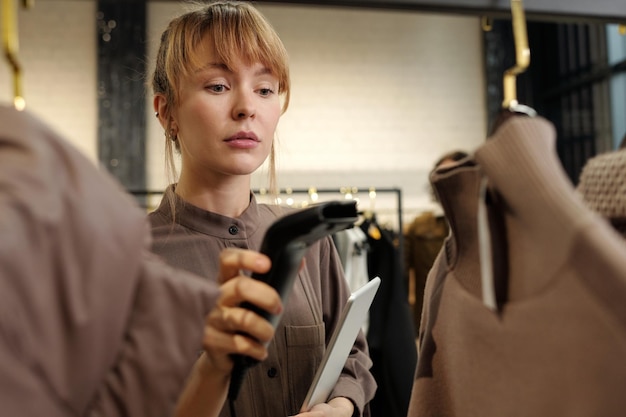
xmin=360 ymin=219 xmax=417 ymax=417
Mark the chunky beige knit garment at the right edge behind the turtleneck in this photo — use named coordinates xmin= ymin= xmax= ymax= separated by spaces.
xmin=576 ymin=149 xmax=626 ymax=237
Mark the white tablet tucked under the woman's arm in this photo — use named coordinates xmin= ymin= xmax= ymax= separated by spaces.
xmin=300 ymin=277 xmax=380 ymax=413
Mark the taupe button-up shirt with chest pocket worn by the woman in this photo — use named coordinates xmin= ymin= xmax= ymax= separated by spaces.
xmin=149 ymin=186 xmax=376 ymax=417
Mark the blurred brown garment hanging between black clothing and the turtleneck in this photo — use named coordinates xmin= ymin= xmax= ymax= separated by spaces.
xmin=404 ymin=211 xmax=448 ymax=334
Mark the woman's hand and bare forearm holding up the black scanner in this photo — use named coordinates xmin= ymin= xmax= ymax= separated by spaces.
xmin=175 ymin=249 xmax=282 ymax=417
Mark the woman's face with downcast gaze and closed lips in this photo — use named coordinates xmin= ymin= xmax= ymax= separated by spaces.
xmin=172 ymin=37 xmax=281 ymax=179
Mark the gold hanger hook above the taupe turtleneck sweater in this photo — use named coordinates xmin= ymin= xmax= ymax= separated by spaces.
xmin=502 ymin=0 xmax=530 ymax=109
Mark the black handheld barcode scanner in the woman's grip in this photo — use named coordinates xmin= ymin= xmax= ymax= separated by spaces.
xmin=228 ymin=200 xmax=358 ymax=401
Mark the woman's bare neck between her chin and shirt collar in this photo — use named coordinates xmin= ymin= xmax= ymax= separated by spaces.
xmin=176 ymin=174 xmax=250 ymax=218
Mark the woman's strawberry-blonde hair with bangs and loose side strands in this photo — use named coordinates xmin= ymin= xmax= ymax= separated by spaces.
xmin=152 ymin=1 xmax=291 ymax=196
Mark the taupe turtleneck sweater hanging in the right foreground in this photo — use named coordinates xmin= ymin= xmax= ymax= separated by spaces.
xmin=408 ymin=117 xmax=626 ymax=417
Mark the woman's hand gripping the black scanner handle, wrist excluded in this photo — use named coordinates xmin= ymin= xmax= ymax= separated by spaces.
xmin=203 ymin=248 xmax=282 ymax=374
